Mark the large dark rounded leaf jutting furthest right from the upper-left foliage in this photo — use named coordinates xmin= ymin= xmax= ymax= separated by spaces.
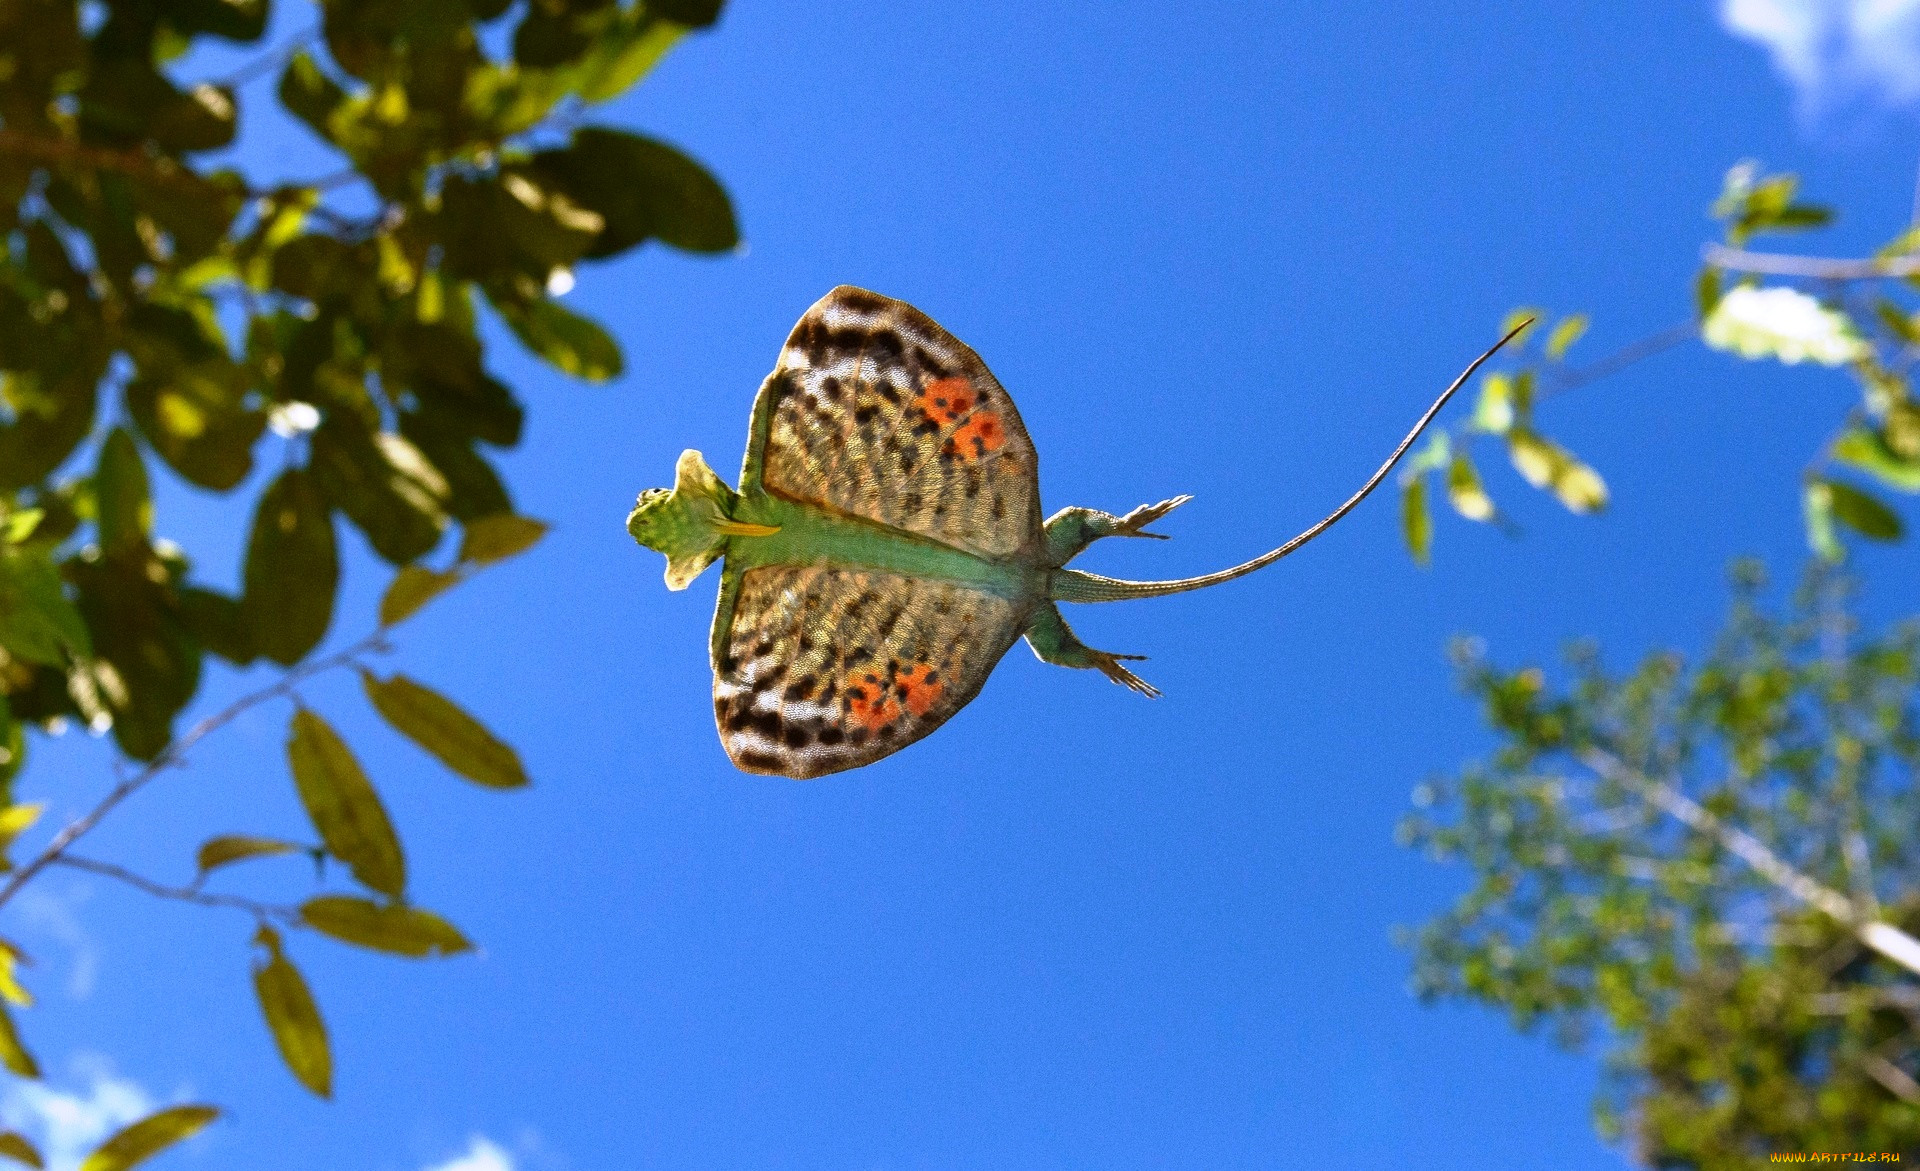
xmin=534 ymin=127 xmax=739 ymax=259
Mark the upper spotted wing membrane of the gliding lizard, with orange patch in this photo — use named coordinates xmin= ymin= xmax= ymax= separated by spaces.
xmin=741 ymin=286 xmax=1041 ymax=557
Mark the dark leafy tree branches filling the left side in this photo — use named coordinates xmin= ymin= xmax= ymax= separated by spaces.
xmin=0 ymin=0 xmax=737 ymax=1151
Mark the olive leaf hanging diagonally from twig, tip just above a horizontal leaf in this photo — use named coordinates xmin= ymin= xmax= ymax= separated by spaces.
xmin=286 ymin=708 xmax=407 ymax=898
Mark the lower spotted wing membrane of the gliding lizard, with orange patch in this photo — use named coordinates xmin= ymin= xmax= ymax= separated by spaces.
xmin=714 ymin=566 xmax=1025 ymax=777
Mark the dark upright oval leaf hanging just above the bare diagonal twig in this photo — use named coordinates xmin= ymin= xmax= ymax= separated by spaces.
xmin=240 ymin=468 xmax=340 ymax=666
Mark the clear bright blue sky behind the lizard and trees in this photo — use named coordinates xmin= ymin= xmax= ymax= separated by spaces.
xmin=6 ymin=0 xmax=1920 ymax=1171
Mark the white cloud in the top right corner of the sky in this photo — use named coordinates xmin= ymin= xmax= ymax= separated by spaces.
xmin=1720 ymin=0 xmax=1920 ymax=121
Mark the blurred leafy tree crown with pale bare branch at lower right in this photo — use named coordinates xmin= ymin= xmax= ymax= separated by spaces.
xmin=1402 ymin=568 xmax=1920 ymax=1169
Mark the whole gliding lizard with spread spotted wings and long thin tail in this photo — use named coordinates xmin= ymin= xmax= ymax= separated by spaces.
xmin=626 ymin=284 xmax=1524 ymax=777
